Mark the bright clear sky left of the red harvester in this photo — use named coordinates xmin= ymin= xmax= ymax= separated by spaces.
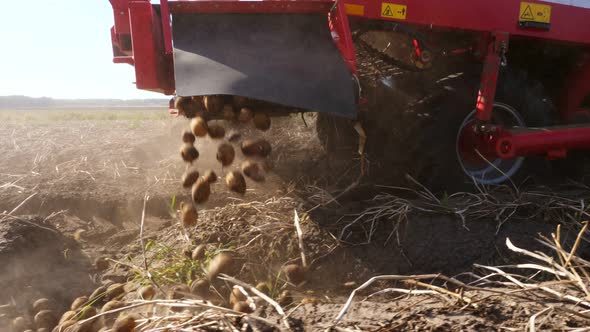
xmin=0 ymin=0 xmax=164 ymax=99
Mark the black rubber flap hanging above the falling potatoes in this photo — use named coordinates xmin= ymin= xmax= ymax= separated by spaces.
xmin=172 ymin=14 xmax=356 ymax=118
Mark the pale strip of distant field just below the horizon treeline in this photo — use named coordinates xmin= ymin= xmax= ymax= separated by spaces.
xmin=0 ymin=107 xmax=170 ymax=125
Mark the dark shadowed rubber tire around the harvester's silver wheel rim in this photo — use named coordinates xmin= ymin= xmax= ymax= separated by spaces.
xmin=409 ymin=68 xmax=556 ymax=193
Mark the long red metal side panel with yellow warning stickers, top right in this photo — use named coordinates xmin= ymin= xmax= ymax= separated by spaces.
xmin=344 ymin=0 xmax=590 ymax=43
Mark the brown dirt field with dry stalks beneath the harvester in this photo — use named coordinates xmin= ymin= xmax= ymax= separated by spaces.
xmin=0 ymin=109 xmax=590 ymax=331
